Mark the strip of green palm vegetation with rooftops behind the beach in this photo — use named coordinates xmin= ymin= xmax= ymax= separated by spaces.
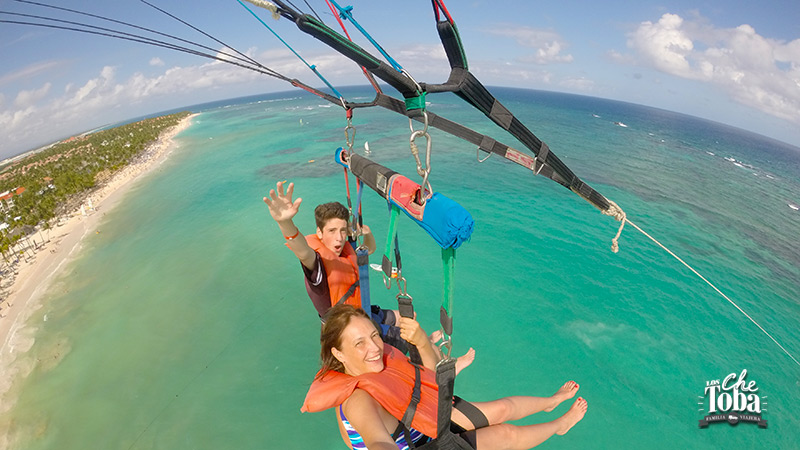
xmin=0 ymin=112 xmax=191 ymax=257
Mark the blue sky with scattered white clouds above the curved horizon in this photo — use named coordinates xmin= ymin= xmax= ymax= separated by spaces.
xmin=0 ymin=0 xmax=800 ymax=159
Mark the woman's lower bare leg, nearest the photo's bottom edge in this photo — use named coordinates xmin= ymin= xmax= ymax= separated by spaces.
xmin=476 ymin=397 xmax=588 ymax=450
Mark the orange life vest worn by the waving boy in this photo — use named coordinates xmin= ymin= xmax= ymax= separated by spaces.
xmin=306 ymin=234 xmax=361 ymax=308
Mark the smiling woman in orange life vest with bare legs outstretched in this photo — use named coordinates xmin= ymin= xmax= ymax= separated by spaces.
xmin=303 ymin=305 xmax=588 ymax=450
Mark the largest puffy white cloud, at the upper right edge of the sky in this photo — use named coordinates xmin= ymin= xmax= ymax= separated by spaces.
xmin=628 ymin=14 xmax=800 ymax=124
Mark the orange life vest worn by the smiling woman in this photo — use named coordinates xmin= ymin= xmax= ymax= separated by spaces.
xmin=300 ymin=344 xmax=439 ymax=438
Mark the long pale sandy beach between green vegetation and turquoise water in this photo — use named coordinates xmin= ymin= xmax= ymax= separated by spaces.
xmin=0 ymin=114 xmax=196 ymax=400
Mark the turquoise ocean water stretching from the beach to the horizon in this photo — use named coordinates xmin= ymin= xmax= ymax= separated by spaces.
xmin=0 ymin=88 xmax=800 ymax=450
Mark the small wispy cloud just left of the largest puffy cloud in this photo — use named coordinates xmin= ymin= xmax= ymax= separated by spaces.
xmin=488 ymin=24 xmax=573 ymax=64
